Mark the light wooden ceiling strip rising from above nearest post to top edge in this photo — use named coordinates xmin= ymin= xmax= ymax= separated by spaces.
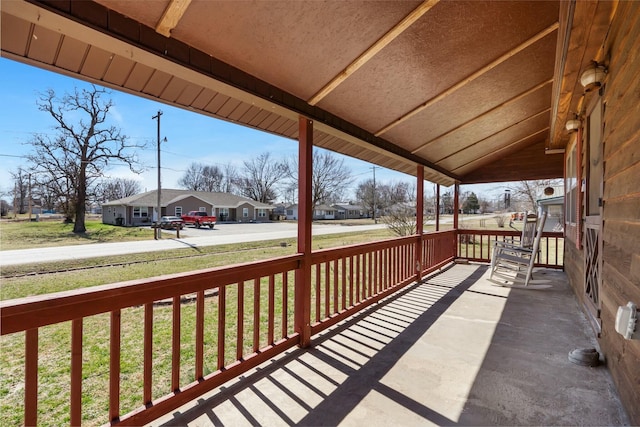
xmin=307 ymin=0 xmax=440 ymax=105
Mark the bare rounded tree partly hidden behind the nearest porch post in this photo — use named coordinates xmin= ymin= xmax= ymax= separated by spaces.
xmin=285 ymin=149 xmax=351 ymax=206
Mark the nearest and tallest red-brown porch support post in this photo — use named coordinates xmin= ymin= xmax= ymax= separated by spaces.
xmin=295 ymin=116 xmax=313 ymax=347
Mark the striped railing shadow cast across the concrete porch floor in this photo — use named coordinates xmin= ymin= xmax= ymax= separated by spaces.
xmin=151 ymin=265 xmax=487 ymax=426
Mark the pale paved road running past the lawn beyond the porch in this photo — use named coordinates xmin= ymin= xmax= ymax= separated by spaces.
xmin=0 ymin=223 xmax=385 ymax=267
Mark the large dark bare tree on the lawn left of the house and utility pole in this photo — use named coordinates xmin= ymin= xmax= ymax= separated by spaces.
xmin=28 ymin=86 xmax=143 ymax=233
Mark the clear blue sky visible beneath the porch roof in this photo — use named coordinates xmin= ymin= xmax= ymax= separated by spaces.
xmin=0 ymin=58 xmax=498 ymax=202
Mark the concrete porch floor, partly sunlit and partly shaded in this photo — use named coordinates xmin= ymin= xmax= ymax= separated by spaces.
xmin=151 ymin=264 xmax=629 ymax=427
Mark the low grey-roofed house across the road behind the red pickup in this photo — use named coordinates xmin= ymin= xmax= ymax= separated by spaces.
xmin=102 ymin=189 xmax=274 ymax=226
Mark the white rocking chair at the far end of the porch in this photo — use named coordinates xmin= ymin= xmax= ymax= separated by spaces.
xmin=489 ymin=212 xmax=551 ymax=289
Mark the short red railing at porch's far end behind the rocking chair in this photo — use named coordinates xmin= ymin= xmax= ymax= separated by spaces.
xmin=458 ymin=229 xmax=564 ymax=269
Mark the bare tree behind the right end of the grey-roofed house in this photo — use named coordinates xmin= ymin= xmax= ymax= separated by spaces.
xmin=240 ymin=153 xmax=286 ymax=203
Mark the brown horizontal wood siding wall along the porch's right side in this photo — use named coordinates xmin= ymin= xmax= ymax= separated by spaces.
xmin=565 ymin=2 xmax=640 ymax=425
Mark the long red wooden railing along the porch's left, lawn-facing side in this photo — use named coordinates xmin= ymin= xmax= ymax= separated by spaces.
xmin=0 ymin=230 xmax=456 ymax=425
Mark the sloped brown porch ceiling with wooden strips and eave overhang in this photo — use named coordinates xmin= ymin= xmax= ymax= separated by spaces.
xmin=1 ymin=0 xmax=615 ymax=185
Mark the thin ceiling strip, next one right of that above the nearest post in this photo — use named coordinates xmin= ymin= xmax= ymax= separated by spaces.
xmin=374 ymin=22 xmax=559 ymax=136
